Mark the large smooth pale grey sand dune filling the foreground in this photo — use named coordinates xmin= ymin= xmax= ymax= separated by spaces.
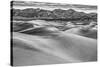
xmin=13 ymin=32 xmax=97 ymax=65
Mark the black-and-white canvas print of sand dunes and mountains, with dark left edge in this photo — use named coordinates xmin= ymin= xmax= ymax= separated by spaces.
xmin=11 ymin=1 xmax=98 ymax=66
